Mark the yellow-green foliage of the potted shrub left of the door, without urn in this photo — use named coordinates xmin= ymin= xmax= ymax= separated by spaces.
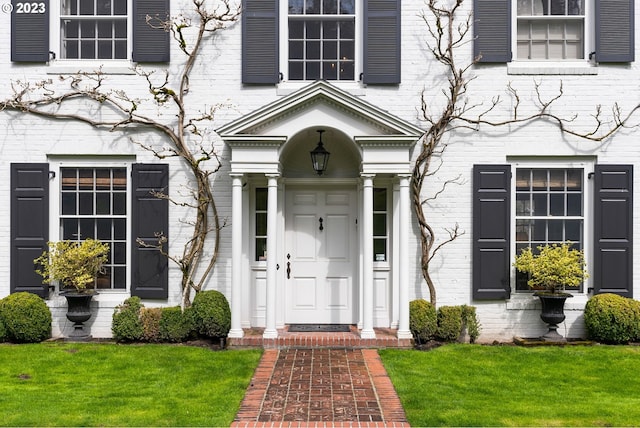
xmin=33 ymin=239 xmax=109 ymax=292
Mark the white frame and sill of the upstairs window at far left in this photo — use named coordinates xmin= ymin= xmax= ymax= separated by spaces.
xmin=49 ymin=0 xmax=133 ymax=74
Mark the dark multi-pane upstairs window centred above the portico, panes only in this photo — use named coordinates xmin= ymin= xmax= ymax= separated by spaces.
xmin=288 ymin=0 xmax=355 ymax=80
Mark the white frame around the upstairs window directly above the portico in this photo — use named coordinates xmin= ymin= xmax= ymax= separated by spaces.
xmin=279 ymin=0 xmax=364 ymax=86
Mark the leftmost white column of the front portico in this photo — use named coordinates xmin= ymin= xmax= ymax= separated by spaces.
xmin=229 ymin=174 xmax=244 ymax=337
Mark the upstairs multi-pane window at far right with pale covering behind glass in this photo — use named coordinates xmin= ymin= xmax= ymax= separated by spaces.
xmin=517 ymin=0 xmax=585 ymax=60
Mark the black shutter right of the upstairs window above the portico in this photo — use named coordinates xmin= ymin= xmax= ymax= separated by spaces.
xmin=362 ymin=0 xmax=401 ymax=85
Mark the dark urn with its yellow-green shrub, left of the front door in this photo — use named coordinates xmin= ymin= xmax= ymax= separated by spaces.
xmin=34 ymin=239 xmax=109 ymax=340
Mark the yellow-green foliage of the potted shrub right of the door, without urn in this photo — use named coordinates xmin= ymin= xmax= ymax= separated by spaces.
xmin=513 ymin=242 xmax=589 ymax=293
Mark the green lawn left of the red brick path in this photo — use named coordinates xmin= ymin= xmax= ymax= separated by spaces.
xmin=0 ymin=343 xmax=261 ymax=426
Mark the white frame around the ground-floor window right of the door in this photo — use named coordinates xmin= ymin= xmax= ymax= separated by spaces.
xmin=509 ymin=159 xmax=595 ymax=297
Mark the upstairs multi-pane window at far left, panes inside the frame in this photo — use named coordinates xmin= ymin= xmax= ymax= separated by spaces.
xmin=60 ymin=0 xmax=127 ymax=59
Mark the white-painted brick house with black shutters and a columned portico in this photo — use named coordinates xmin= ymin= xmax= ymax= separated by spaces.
xmin=0 ymin=0 xmax=640 ymax=341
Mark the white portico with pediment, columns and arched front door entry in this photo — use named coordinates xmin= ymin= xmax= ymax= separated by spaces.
xmin=218 ymin=81 xmax=423 ymax=339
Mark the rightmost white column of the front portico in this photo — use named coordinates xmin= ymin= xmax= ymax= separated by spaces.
xmin=398 ymin=174 xmax=413 ymax=339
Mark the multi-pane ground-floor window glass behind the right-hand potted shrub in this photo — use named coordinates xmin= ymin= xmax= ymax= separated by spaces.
xmin=515 ymin=168 xmax=584 ymax=290
